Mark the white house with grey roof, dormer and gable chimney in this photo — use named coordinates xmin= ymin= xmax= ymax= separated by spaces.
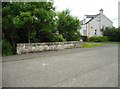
xmin=80 ymin=9 xmax=113 ymax=37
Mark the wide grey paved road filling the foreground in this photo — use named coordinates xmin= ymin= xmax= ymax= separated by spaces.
xmin=2 ymin=44 xmax=118 ymax=87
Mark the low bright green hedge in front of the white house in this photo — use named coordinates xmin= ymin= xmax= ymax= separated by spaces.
xmin=89 ymin=36 xmax=109 ymax=42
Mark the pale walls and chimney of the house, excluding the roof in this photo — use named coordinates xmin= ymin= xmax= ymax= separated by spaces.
xmin=80 ymin=11 xmax=113 ymax=37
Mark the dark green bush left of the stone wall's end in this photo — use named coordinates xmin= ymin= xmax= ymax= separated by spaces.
xmin=2 ymin=40 xmax=14 ymax=56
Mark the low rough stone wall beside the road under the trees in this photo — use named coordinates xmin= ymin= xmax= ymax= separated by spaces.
xmin=17 ymin=41 xmax=82 ymax=54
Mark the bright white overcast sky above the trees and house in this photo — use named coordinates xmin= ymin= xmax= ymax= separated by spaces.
xmin=54 ymin=0 xmax=120 ymax=27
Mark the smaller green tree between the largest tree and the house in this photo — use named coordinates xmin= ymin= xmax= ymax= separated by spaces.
xmin=57 ymin=10 xmax=80 ymax=41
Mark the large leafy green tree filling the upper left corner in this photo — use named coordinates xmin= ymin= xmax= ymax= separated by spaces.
xmin=2 ymin=2 xmax=56 ymax=44
